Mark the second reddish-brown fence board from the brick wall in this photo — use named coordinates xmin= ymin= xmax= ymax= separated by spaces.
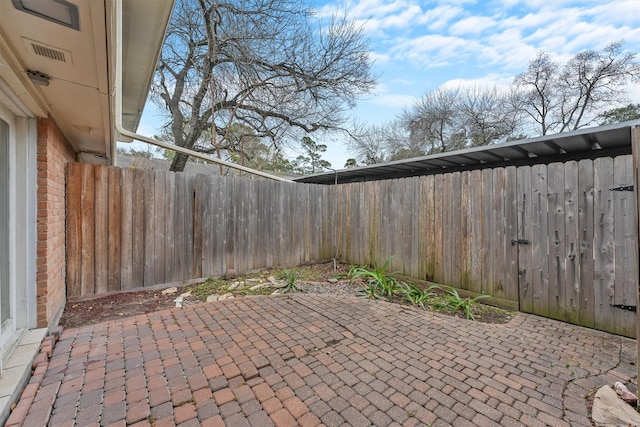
xmin=80 ymin=164 xmax=95 ymax=296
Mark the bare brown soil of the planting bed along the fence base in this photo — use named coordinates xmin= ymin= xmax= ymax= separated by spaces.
xmin=60 ymin=263 xmax=515 ymax=328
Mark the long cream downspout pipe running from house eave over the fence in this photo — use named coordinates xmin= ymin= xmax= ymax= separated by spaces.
xmin=112 ymin=0 xmax=292 ymax=182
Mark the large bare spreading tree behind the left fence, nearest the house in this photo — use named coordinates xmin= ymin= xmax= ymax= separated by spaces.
xmin=153 ymin=0 xmax=375 ymax=171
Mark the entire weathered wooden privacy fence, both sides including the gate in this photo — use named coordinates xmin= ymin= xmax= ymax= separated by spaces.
xmin=67 ymin=156 xmax=638 ymax=337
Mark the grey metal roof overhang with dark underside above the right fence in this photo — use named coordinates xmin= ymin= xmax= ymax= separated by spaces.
xmin=294 ymin=120 xmax=640 ymax=185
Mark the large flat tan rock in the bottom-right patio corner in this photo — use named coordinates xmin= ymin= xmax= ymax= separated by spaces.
xmin=591 ymin=385 xmax=640 ymax=427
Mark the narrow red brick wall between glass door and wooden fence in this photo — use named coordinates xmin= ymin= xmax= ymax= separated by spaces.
xmin=36 ymin=119 xmax=76 ymax=327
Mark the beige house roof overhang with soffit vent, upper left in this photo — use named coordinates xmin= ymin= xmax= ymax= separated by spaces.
xmin=0 ymin=0 xmax=175 ymax=163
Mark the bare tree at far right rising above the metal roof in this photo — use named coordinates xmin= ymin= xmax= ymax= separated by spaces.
xmin=514 ymin=41 xmax=640 ymax=135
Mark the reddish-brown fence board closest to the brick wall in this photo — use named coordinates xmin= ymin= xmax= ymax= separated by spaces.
xmin=66 ymin=163 xmax=82 ymax=298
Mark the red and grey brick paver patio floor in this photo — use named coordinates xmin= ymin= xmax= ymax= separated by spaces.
xmin=8 ymin=294 xmax=636 ymax=426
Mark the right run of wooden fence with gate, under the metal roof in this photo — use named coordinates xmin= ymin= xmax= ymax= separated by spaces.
xmin=336 ymin=156 xmax=638 ymax=337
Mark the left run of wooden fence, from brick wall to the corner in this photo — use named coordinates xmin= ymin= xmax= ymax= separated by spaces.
xmin=67 ymin=163 xmax=333 ymax=298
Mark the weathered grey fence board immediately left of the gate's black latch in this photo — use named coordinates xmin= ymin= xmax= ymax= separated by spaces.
xmin=502 ymin=166 xmax=518 ymax=302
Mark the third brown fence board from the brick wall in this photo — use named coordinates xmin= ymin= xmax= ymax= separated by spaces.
xmin=92 ymin=165 xmax=111 ymax=294
